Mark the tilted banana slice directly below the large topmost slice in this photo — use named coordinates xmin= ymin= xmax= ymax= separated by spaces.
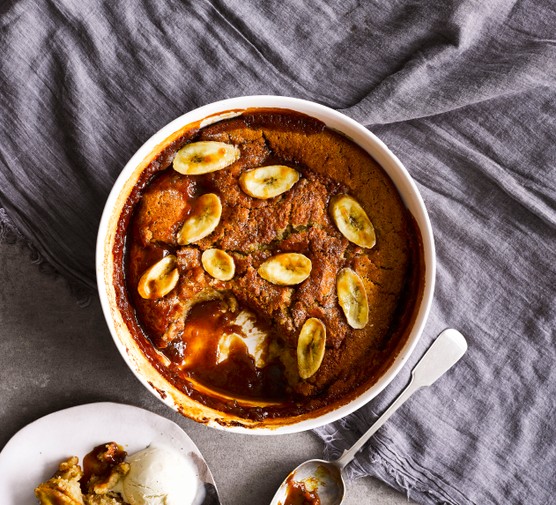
xmin=178 ymin=193 xmax=222 ymax=245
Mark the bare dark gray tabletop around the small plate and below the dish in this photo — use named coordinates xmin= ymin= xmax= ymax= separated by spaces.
xmin=0 ymin=243 xmax=410 ymax=505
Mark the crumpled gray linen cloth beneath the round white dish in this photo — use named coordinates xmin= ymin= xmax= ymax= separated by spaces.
xmin=0 ymin=0 xmax=556 ymax=505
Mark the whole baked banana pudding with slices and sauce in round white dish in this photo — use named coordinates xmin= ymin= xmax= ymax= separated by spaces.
xmin=112 ymin=108 xmax=424 ymax=426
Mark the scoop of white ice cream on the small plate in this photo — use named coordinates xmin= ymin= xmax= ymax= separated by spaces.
xmin=117 ymin=447 xmax=198 ymax=505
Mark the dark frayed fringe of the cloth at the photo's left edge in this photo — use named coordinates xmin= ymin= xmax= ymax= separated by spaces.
xmin=0 ymin=207 xmax=93 ymax=308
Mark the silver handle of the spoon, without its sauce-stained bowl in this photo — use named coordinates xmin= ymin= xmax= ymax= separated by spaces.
xmin=336 ymin=328 xmax=467 ymax=468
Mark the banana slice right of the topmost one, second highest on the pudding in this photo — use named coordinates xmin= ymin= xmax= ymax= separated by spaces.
xmin=239 ymin=165 xmax=299 ymax=200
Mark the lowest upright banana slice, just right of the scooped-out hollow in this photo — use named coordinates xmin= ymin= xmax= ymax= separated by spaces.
xmin=297 ymin=317 xmax=326 ymax=379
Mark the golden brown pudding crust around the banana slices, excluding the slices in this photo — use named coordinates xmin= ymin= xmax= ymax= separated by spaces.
xmin=115 ymin=110 xmax=422 ymax=419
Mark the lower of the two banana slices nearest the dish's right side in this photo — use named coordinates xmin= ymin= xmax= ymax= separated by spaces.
xmin=336 ymin=268 xmax=369 ymax=330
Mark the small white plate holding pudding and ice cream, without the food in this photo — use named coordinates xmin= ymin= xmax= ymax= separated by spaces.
xmin=0 ymin=402 xmax=220 ymax=505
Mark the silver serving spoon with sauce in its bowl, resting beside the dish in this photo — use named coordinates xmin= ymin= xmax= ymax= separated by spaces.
xmin=270 ymin=328 xmax=467 ymax=505
